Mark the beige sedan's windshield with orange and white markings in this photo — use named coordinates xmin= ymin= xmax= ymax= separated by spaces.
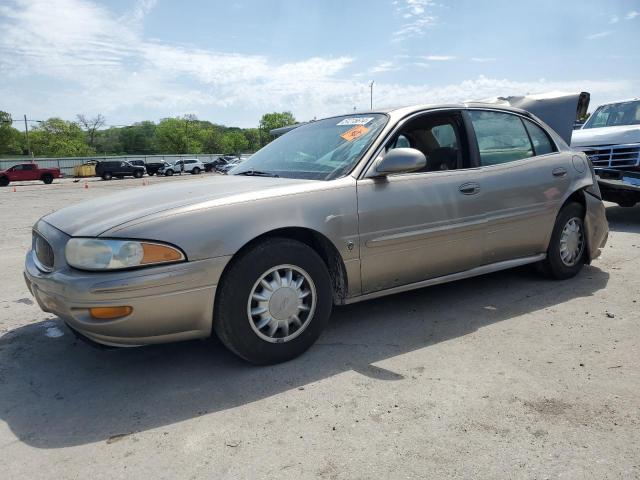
xmin=229 ymin=113 xmax=387 ymax=180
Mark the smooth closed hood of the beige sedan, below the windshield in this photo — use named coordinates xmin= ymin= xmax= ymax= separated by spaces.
xmin=43 ymin=175 xmax=316 ymax=236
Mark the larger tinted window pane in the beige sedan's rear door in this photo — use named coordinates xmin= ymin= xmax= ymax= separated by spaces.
xmin=469 ymin=110 xmax=533 ymax=165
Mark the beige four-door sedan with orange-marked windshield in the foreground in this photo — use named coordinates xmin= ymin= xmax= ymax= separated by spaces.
xmin=25 ymin=103 xmax=608 ymax=364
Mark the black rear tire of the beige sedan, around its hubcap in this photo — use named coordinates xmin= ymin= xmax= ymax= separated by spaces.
xmin=540 ymin=202 xmax=587 ymax=280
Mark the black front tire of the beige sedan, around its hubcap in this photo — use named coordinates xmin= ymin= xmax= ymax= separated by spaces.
xmin=213 ymin=238 xmax=333 ymax=365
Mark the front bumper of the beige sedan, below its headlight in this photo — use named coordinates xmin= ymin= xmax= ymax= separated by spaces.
xmin=24 ymin=232 xmax=230 ymax=346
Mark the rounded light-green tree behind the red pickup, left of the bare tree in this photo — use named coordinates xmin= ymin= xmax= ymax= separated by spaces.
xmin=30 ymin=118 xmax=95 ymax=157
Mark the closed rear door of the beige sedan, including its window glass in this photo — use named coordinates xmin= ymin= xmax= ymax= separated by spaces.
xmin=469 ymin=109 xmax=571 ymax=264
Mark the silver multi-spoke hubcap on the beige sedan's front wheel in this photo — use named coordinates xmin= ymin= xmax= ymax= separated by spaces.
xmin=247 ymin=265 xmax=316 ymax=343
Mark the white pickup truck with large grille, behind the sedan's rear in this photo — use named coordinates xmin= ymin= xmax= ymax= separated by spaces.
xmin=571 ymin=98 xmax=640 ymax=207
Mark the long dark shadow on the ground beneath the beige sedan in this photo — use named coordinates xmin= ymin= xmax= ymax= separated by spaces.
xmin=0 ymin=266 xmax=609 ymax=448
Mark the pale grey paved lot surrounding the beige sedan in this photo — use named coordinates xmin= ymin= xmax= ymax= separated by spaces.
xmin=0 ymin=175 xmax=640 ymax=479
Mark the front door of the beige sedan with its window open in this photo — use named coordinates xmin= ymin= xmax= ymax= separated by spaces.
xmin=357 ymin=111 xmax=485 ymax=293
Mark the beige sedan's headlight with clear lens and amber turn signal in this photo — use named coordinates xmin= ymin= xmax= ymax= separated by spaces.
xmin=65 ymin=238 xmax=186 ymax=270
